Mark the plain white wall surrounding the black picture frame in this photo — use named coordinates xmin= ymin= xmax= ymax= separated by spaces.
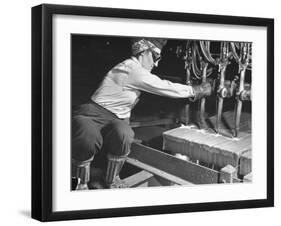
xmin=0 ymin=0 xmax=276 ymax=226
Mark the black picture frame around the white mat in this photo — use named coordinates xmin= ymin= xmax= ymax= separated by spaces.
xmin=32 ymin=4 xmax=274 ymax=221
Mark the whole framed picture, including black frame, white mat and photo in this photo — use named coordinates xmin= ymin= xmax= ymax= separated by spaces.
xmin=32 ymin=4 xmax=274 ymax=221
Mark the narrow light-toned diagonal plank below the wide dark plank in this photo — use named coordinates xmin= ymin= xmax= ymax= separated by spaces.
xmin=126 ymin=157 xmax=192 ymax=185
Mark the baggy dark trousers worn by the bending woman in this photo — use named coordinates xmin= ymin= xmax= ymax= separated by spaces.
xmin=72 ymin=101 xmax=134 ymax=163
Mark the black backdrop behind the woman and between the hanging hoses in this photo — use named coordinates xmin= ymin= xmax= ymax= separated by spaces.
xmin=71 ymin=34 xmax=251 ymax=123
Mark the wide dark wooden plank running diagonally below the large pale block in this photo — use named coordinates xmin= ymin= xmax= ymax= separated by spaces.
xmin=129 ymin=143 xmax=219 ymax=184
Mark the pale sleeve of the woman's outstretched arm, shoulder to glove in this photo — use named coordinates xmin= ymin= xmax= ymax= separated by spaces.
xmin=127 ymin=64 xmax=194 ymax=98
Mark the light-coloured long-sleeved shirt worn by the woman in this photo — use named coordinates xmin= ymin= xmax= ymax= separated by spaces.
xmin=91 ymin=57 xmax=194 ymax=119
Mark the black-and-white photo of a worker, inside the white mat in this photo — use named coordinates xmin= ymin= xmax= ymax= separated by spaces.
xmin=71 ymin=34 xmax=254 ymax=190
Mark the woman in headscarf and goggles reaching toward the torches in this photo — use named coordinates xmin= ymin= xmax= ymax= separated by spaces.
xmin=72 ymin=38 xmax=211 ymax=189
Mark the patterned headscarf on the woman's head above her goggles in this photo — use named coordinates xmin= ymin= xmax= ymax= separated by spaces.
xmin=132 ymin=38 xmax=167 ymax=55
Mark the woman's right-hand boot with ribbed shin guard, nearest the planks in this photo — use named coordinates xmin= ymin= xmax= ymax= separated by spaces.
xmin=105 ymin=154 xmax=128 ymax=188
